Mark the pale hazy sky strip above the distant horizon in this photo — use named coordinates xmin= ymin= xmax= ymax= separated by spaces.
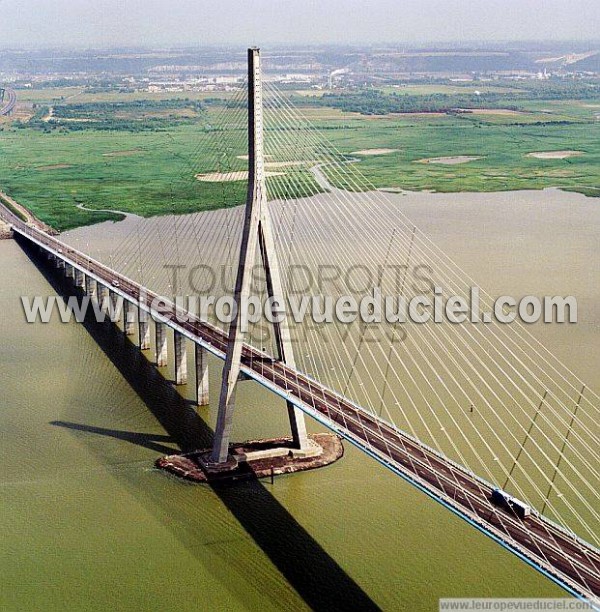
xmin=0 ymin=0 xmax=600 ymax=47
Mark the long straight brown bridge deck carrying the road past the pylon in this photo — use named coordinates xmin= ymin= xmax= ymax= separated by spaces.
xmin=0 ymin=201 xmax=600 ymax=599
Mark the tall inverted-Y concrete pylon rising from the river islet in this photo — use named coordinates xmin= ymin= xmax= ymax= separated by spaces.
xmin=210 ymin=49 xmax=309 ymax=464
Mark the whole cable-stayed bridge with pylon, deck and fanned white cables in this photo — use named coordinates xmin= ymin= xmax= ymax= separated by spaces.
xmin=4 ymin=50 xmax=600 ymax=598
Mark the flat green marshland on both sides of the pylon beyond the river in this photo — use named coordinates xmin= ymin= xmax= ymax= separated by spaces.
xmin=0 ymin=87 xmax=600 ymax=230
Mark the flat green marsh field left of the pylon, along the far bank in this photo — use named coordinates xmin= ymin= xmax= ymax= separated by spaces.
xmin=0 ymin=126 xmax=248 ymax=230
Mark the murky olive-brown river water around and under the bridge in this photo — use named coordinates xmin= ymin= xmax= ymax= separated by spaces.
xmin=0 ymin=190 xmax=600 ymax=611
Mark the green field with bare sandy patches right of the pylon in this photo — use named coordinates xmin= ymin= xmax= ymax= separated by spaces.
xmin=328 ymin=119 xmax=600 ymax=195
